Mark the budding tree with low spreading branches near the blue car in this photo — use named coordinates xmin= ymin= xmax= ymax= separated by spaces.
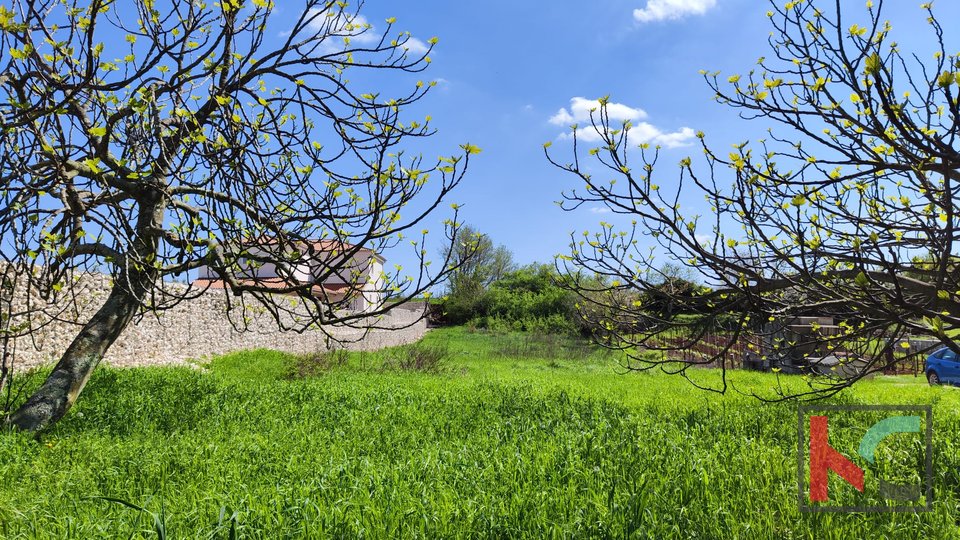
xmin=546 ymin=0 xmax=960 ymax=398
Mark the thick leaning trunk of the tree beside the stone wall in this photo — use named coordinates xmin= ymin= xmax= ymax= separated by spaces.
xmin=8 ymin=280 xmax=142 ymax=431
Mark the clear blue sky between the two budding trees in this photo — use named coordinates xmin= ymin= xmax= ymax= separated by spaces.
xmin=284 ymin=0 xmax=960 ymax=278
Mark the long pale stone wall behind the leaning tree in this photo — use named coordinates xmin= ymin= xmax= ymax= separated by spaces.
xmin=0 ymin=274 xmax=427 ymax=369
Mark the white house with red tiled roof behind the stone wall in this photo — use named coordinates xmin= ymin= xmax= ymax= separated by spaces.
xmin=194 ymin=240 xmax=385 ymax=311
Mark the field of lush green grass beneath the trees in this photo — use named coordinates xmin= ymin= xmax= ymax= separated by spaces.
xmin=0 ymin=328 xmax=960 ymax=539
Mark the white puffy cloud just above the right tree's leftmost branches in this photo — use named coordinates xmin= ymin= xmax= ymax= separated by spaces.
xmin=548 ymin=97 xmax=696 ymax=148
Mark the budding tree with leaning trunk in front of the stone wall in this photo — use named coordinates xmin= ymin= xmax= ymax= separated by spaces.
xmin=0 ymin=0 xmax=478 ymax=430
